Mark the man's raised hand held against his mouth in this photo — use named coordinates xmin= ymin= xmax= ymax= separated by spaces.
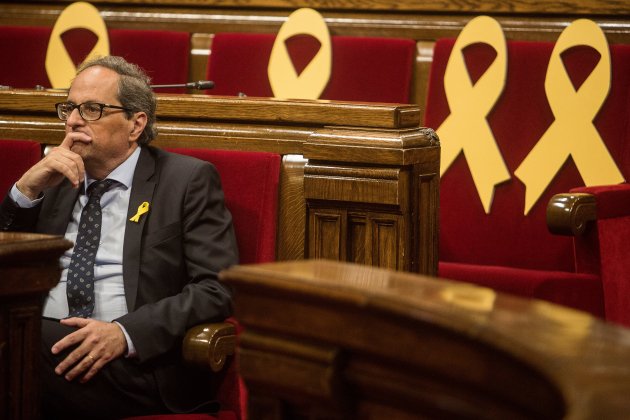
xmin=16 ymin=132 xmax=89 ymax=200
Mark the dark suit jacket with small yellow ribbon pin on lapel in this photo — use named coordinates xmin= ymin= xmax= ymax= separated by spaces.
xmin=0 ymin=146 xmax=238 ymax=411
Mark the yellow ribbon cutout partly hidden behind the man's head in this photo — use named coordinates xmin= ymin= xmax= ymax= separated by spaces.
xmin=46 ymin=2 xmax=109 ymax=89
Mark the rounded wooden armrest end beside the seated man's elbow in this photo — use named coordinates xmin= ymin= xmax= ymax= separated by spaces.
xmin=182 ymin=322 xmax=236 ymax=372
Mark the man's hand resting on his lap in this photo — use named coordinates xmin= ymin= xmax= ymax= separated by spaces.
xmin=51 ymin=318 xmax=127 ymax=383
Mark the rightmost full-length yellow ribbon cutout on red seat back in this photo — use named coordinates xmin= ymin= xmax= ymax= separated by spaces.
xmin=514 ymin=19 xmax=624 ymax=214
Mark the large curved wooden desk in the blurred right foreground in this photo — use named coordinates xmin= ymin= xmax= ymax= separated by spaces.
xmin=222 ymin=260 xmax=630 ymax=420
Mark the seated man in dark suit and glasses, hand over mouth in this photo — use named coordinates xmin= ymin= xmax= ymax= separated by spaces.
xmin=0 ymin=57 xmax=238 ymax=418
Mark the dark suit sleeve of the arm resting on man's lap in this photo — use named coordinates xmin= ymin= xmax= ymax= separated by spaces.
xmin=116 ymin=162 xmax=238 ymax=362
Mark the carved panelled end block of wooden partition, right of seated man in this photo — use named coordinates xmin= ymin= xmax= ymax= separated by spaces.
xmin=304 ymin=127 xmax=439 ymax=275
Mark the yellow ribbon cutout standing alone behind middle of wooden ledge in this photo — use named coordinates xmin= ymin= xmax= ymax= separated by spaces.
xmin=267 ymin=8 xmax=332 ymax=99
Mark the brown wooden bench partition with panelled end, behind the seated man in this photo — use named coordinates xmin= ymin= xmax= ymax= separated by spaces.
xmin=0 ymin=90 xmax=440 ymax=274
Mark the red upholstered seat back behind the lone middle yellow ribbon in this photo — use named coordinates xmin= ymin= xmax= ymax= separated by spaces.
xmin=208 ymin=33 xmax=415 ymax=103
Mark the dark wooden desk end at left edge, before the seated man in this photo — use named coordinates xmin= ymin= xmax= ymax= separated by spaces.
xmin=0 ymin=232 xmax=72 ymax=420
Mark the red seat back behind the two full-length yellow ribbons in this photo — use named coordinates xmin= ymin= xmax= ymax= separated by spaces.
xmin=425 ymin=39 xmax=630 ymax=272
